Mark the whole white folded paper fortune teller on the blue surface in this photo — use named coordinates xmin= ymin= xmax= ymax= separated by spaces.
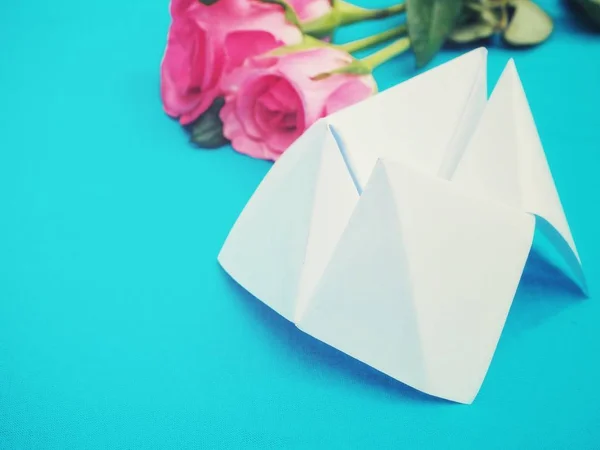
xmin=219 ymin=48 xmax=586 ymax=403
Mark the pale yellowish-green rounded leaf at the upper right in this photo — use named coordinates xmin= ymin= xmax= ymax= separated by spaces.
xmin=502 ymin=0 xmax=553 ymax=46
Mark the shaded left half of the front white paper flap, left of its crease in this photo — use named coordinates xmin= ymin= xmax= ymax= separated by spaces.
xmin=296 ymin=162 xmax=426 ymax=388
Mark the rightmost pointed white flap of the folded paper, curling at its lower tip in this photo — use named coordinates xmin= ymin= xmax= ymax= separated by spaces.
xmin=451 ymin=60 xmax=580 ymax=290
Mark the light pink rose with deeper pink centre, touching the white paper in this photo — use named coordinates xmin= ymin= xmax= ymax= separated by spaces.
xmin=220 ymin=47 xmax=376 ymax=160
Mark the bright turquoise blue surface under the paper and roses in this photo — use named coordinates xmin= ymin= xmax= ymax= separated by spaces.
xmin=0 ymin=0 xmax=600 ymax=449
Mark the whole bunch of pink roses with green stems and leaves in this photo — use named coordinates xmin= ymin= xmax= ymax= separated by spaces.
xmin=161 ymin=0 xmax=595 ymax=160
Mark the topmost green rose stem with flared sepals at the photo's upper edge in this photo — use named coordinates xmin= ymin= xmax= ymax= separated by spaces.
xmin=301 ymin=0 xmax=406 ymax=37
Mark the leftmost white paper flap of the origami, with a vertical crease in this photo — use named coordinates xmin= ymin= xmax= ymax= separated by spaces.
xmin=218 ymin=121 xmax=359 ymax=321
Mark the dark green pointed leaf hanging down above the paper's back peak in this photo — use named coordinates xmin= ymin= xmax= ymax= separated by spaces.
xmin=406 ymin=0 xmax=463 ymax=67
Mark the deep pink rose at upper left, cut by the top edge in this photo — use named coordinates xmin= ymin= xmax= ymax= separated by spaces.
xmin=161 ymin=0 xmax=302 ymax=125
